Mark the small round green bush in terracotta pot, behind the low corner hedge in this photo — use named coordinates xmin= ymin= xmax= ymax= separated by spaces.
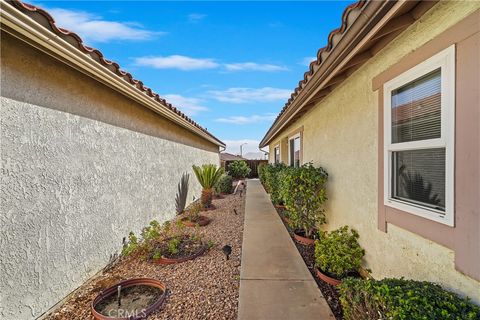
xmin=315 ymin=226 xmax=365 ymax=286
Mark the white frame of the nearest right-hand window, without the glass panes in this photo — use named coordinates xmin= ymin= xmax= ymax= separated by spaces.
xmin=383 ymin=45 xmax=455 ymax=227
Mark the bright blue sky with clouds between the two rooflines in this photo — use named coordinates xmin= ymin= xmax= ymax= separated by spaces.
xmin=34 ymin=1 xmax=351 ymax=153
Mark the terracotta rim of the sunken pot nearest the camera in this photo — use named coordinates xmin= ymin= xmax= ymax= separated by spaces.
xmin=90 ymin=278 xmax=167 ymax=320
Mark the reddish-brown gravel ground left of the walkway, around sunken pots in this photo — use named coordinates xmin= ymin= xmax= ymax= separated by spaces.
xmin=46 ymin=195 xmax=245 ymax=320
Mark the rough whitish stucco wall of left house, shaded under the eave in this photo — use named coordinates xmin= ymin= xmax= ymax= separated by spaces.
xmin=0 ymin=33 xmax=219 ymax=320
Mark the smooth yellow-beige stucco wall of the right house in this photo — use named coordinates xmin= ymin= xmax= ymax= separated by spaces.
xmin=270 ymin=1 xmax=480 ymax=303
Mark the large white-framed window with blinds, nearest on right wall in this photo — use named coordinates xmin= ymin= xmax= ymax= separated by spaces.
xmin=384 ymin=45 xmax=455 ymax=226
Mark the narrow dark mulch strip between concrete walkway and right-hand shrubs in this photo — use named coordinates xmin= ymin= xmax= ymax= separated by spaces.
xmin=276 ymin=208 xmax=343 ymax=320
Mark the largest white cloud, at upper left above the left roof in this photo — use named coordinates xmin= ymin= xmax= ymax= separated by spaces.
xmin=48 ymin=8 xmax=166 ymax=42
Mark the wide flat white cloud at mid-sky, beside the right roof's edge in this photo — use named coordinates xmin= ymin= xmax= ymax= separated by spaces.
xmin=207 ymin=87 xmax=291 ymax=103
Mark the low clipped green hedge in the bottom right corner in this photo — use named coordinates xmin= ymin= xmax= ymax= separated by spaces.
xmin=339 ymin=278 xmax=480 ymax=320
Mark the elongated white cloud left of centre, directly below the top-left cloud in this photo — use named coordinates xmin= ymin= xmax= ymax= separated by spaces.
xmin=135 ymin=55 xmax=219 ymax=71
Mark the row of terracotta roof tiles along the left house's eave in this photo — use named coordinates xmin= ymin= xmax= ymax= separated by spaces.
xmin=7 ymin=0 xmax=224 ymax=145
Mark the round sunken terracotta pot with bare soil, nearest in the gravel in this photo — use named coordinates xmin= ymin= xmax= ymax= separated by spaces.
xmin=90 ymin=278 xmax=167 ymax=320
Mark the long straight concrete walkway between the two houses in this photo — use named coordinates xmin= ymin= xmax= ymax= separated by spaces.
xmin=238 ymin=180 xmax=335 ymax=320
